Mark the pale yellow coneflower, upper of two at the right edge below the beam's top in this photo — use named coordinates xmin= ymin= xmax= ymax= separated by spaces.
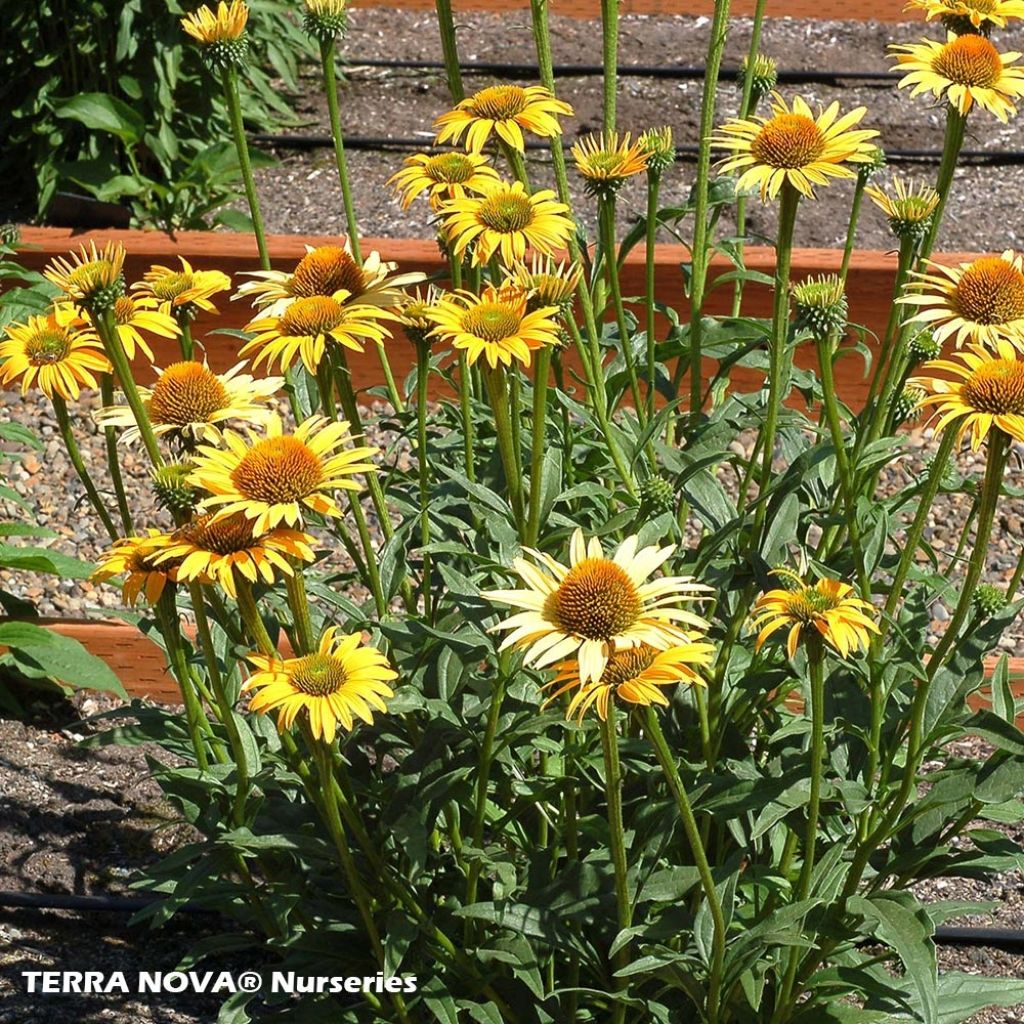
xmin=897 ymin=249 xmax=1024 ymax=347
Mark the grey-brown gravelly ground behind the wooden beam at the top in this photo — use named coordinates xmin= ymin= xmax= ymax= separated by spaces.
xmin=243 ymin=10 xmax=1024 ymax=251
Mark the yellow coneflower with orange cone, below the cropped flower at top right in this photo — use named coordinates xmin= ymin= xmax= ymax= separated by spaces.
xmin=890 ymin=32 xmax=1024 ymax=121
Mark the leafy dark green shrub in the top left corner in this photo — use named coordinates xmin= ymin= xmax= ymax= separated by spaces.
xmin=0 ymin=0 xmax=308 ymax=228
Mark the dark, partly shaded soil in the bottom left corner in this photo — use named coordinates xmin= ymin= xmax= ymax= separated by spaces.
xmin=0 ymin=691 xmax=236 ymax=1024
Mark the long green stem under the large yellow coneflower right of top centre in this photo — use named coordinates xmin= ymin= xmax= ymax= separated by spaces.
xmin=751 ymin=182 xmax=800 ymax=551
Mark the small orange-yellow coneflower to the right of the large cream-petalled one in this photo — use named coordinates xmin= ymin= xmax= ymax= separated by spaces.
xmin=751 ymin=569 xmax=879 ymax=657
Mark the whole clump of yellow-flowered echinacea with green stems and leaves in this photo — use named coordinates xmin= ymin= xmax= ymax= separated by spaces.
xmin=6 ymin=0 xmax=1024 ymax=1024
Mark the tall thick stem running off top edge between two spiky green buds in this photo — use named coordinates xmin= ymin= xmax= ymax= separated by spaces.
xmin=690 ymin=0 xmax=729 ymax=424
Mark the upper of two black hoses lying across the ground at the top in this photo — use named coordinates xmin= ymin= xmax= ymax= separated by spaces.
xmin=348 ymin=59 xmax=899 ymax=85
